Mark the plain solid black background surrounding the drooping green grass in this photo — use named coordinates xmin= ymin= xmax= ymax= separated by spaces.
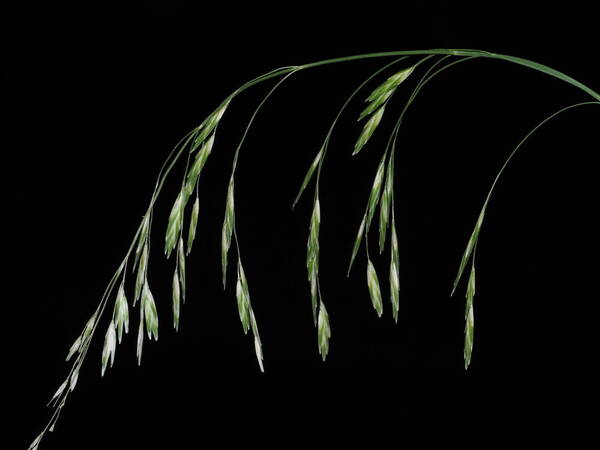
xmin=9 ymin=2 xmax=600 ymax=449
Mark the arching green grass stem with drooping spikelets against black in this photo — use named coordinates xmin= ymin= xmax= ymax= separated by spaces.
xmin=29 ymin=49 xmax=600 ymax=450
